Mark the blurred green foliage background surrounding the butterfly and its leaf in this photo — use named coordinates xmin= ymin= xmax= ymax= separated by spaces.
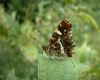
xmin=0 ymin=0 xmax=100 ymax=80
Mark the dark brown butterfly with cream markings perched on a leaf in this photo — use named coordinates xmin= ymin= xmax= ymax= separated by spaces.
xmin=42 ymin=19 xmax=76 ymax=57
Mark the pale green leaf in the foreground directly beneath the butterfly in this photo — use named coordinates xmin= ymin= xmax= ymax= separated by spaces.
xmin=38 ymin=55 xmax=77 ymax=80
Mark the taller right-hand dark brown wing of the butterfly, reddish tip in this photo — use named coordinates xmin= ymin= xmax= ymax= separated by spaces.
xmin=58 ymin=19 xmax=75 ymax=57
